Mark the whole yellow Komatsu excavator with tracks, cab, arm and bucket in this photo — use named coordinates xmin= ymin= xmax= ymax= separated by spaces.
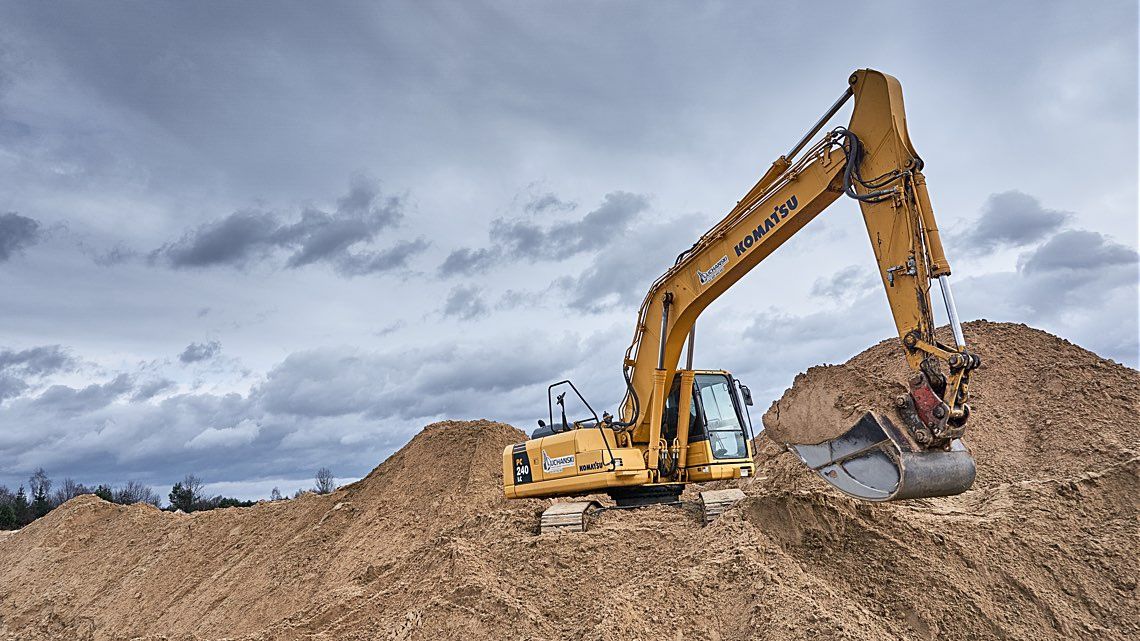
xmin=503 ymin=68 xmax=980 ymax=532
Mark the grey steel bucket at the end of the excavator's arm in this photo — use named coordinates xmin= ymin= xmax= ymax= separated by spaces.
xmin=789 ymin=412 xmax=976 ymax=501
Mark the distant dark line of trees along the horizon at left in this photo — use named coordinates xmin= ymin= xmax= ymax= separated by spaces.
xmin=0 ymin=468 xmax=336 ymax=529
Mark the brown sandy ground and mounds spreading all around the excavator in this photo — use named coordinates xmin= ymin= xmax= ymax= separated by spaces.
xmin=0 ymin=323 xmax=1140 ymax=641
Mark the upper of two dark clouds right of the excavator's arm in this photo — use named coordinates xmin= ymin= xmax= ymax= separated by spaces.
xmin=953 ymin=190 xmax=1072 ymax=255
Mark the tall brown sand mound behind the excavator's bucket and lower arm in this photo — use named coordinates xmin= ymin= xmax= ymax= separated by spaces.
xmin=764 ymin=321 xmax=1140 ymax=485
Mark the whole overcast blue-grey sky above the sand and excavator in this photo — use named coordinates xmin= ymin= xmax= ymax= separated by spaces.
xmin=0 ymin=1 xmax=1138 ymax=497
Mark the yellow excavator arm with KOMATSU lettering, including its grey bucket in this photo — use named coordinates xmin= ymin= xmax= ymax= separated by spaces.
xmin=606 ymin=70 xmax=980 ymax=501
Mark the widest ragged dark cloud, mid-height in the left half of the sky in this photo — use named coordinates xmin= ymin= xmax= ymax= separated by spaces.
xmin=150 ymin=179 xmax=428 ymax=276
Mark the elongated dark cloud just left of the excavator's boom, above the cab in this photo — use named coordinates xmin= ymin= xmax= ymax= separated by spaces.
xmin=491 ymin=192 xmax=649 ymax=260
